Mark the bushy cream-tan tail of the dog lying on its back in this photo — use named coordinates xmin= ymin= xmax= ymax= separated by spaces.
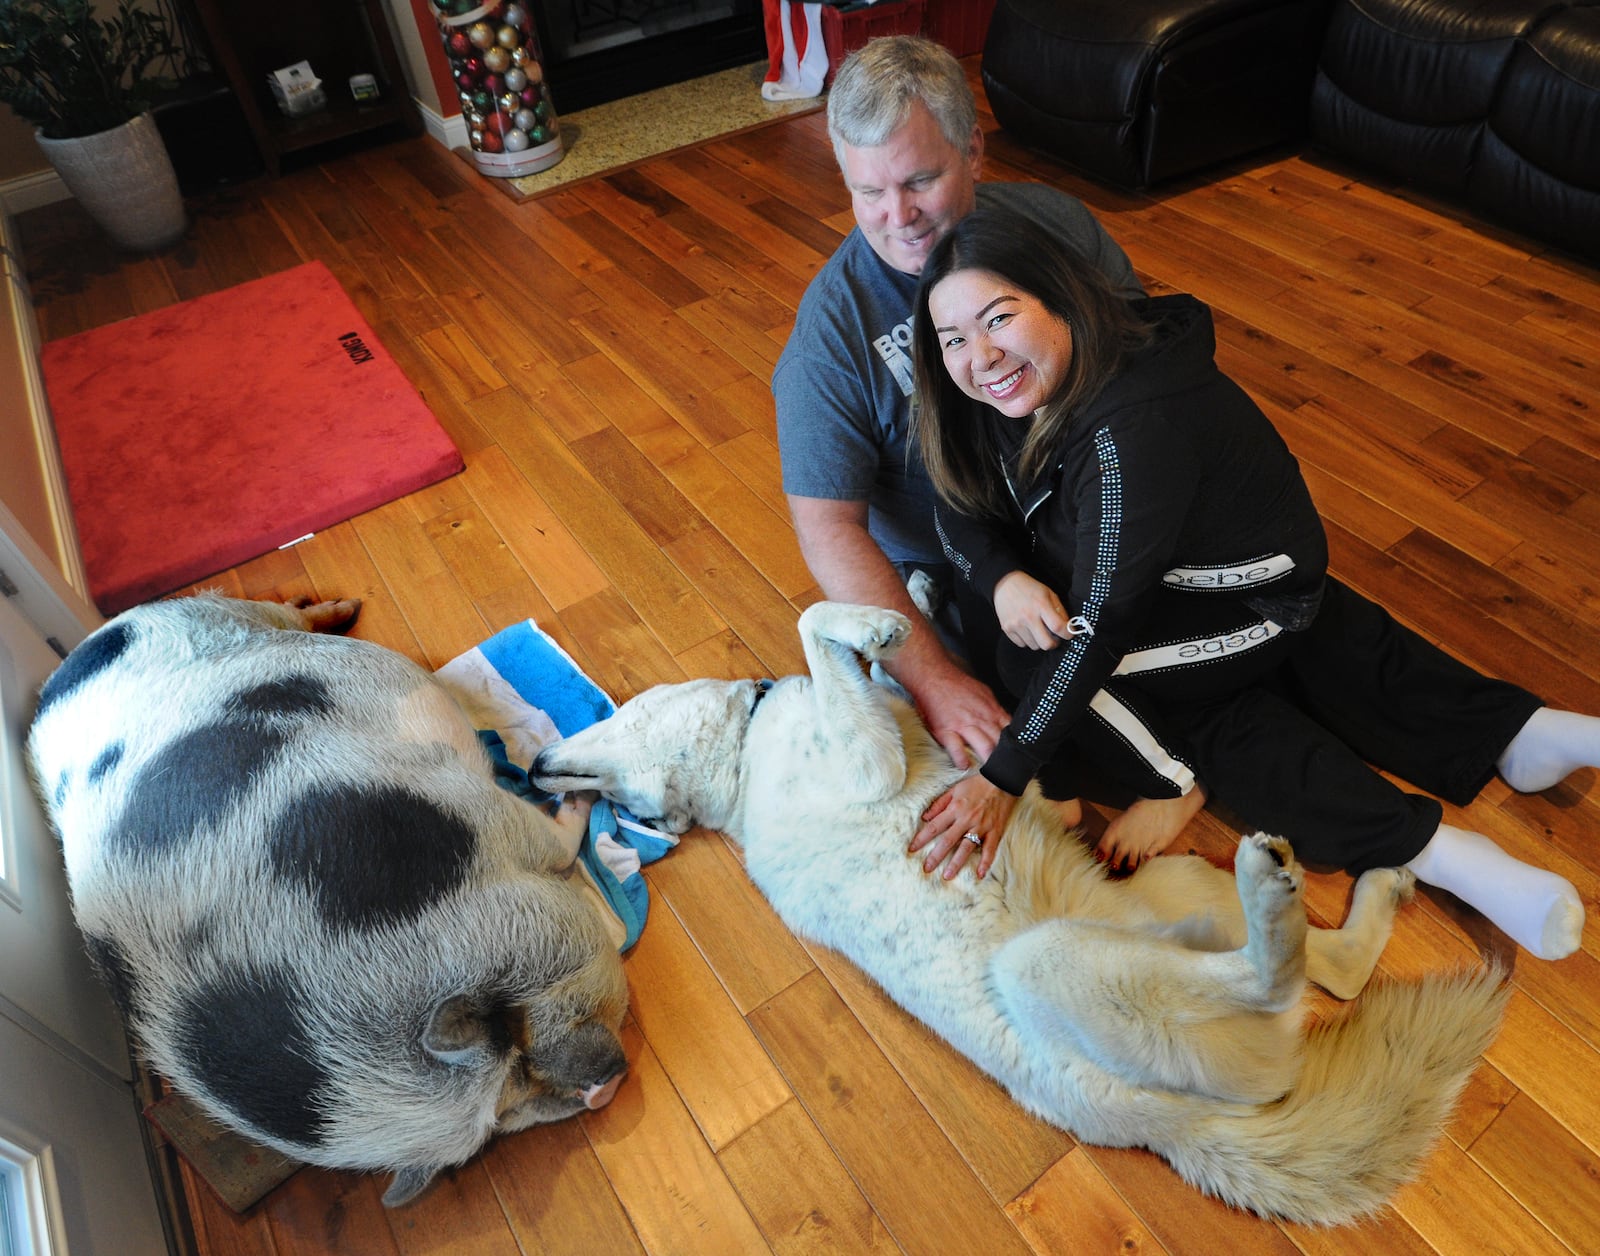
xmin=1157 ymin=968 xmax=1510 ymax=1226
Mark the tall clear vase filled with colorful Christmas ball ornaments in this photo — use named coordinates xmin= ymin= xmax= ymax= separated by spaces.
xmin=429 ymin=0 xmax=563 ymax=179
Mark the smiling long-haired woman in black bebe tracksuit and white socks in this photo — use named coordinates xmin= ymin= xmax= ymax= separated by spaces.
xmin=912 ymin=208 xmax=1600 ymax=958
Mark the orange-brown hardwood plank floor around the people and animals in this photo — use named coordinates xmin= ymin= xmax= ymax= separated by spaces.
xmin=21 ymin=62 xmax=1600 ymax=1256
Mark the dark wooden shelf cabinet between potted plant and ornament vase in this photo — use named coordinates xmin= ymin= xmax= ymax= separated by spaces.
xmin=190 ymin=0 xmax=421 ymax=174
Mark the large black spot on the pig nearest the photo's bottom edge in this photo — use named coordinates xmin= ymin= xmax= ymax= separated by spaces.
xmin=176 ymin=971 xmax=331 ymax=1147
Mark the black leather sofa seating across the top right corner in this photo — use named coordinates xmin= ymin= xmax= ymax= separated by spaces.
xmin=982 ymin=0 xmax=1600 ymax=259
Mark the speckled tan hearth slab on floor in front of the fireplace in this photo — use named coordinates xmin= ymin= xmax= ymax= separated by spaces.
xmin=496 ymin=61 xmax=826 ymax=200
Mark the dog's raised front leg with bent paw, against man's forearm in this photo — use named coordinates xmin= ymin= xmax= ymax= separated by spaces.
xmin=800 ymin=602 xmax=912 ymax=802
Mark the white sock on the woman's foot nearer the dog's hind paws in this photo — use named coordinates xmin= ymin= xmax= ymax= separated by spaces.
xmin=1406 ymin=824 xmax=1584 ymax=960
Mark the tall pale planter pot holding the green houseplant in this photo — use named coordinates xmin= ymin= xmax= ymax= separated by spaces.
xmin=34 ymin=114 xmax=189 ymax=253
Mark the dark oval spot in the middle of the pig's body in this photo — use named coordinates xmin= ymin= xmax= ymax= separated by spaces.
xmin=267 ymin=786 xmax=477 ymax=928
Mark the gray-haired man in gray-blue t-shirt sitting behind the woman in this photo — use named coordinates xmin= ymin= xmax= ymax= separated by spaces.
xmin=773 ymin=37 xmax=1142 ymax=765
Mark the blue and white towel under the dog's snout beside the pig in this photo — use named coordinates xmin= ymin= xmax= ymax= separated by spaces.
xmin=435 ymin=619 xmax=678 ymax=950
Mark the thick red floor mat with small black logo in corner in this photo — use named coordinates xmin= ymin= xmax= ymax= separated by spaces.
xmin=43 ymin=262 xmax=462 ymax=614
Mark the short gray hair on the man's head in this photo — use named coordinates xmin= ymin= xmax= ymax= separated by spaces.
xmin=827 ymin=35 xmax=978 ymax=166
